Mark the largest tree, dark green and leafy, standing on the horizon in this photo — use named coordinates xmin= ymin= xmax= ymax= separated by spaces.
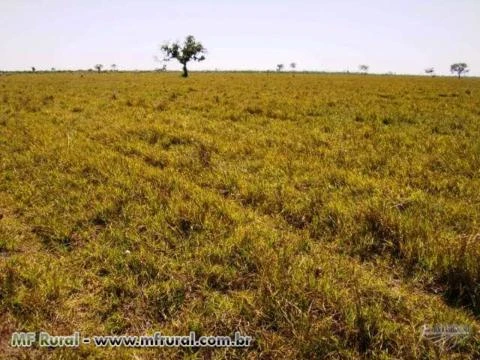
xmin=160 ymin=35 xmax=207 ymax=77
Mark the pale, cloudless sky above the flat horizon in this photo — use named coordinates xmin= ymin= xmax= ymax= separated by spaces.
xmin=0 ymin=0 xmax=480 ymax=76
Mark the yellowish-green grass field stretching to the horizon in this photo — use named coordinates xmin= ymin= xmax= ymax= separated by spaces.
xmin=0 ymin=73 xmax=480 ymax=359
